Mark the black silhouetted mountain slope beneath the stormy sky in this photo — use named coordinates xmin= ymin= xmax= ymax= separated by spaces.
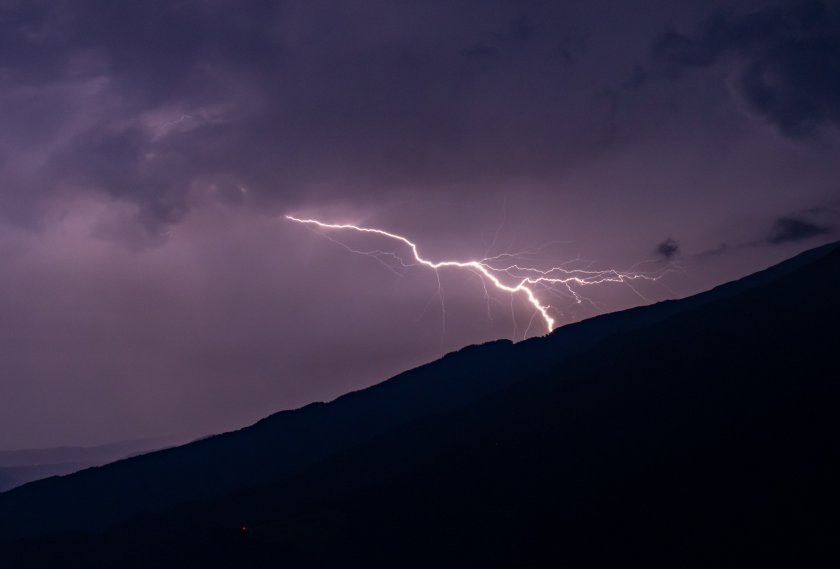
xmin=0 ymin=242 xmax=840 ymax=567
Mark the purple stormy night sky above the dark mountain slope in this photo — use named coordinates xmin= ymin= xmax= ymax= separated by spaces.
xmin=0 ymin=0 xmax=840 ymax=449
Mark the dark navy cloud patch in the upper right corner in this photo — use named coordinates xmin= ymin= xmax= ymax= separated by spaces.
xmin=648 ymin=1 xmax=840 ymax=137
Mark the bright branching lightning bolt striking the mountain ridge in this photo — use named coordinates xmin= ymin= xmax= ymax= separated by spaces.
xmin=286 ymin=215 xmax=662 ymax=332
